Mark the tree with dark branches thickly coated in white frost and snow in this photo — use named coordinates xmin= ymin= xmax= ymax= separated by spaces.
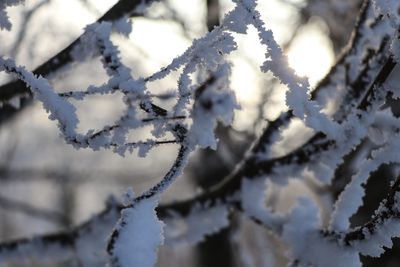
xmin=0 ymin=0 xmax=400 ymax=267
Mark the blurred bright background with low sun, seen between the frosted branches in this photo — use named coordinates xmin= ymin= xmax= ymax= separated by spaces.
xmin=0 ymin=0 xmax=388 ymax=267
